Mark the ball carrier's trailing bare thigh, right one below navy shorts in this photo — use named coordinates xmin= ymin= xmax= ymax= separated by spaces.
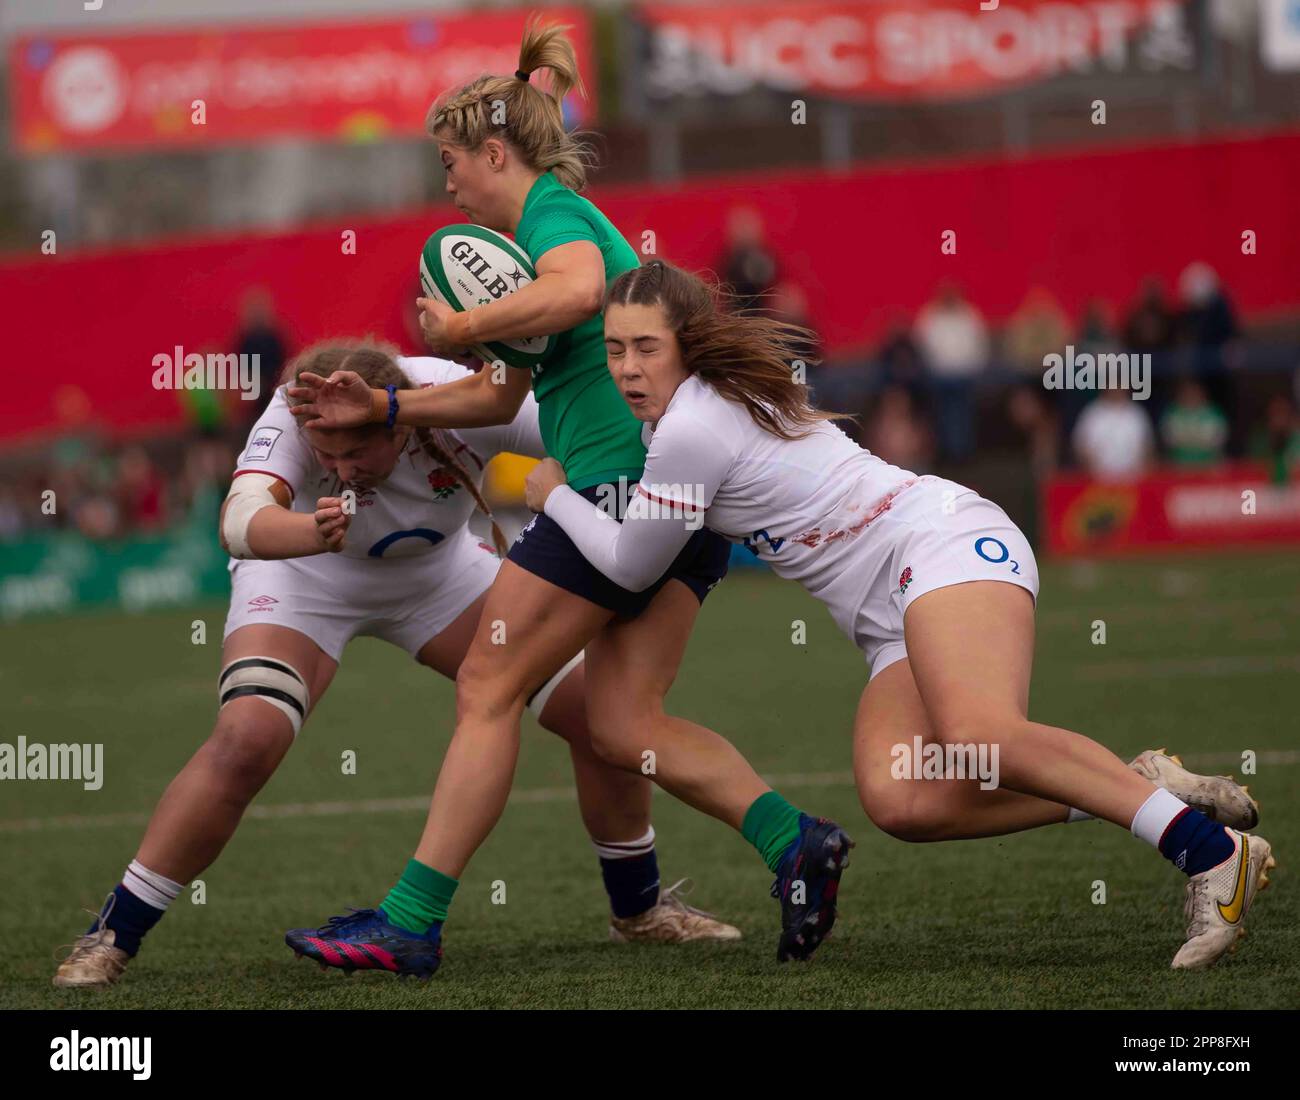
xmin=586 ymin=580 xmax=699 ymax=739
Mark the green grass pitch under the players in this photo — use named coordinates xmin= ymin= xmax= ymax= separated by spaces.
xmin=0 ymin=554 xmax=1300 ymax=1009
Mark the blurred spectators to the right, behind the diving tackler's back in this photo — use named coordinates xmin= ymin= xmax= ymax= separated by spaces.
xmin=718 ymin=208 xmax=1300 ymax=491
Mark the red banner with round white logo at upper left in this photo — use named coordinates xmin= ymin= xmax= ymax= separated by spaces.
xmin=9 ymin=8 xmax=595 ymax=153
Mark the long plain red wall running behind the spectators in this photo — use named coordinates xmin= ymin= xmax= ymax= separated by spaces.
xmin=0 ymin=133 xmax=1300 ymax=446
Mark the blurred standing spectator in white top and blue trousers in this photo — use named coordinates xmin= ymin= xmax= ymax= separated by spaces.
xmin=913 ymin=282 xmax=989 ymax=462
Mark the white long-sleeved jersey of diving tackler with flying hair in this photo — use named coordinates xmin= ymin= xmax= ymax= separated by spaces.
xmin=546 ymin=376 xmax=917 ymax=594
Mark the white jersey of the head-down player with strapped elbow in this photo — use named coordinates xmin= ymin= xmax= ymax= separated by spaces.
xmin=235 ymin=356 xmax=545 ymax=558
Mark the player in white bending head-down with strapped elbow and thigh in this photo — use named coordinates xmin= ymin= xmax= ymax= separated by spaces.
xmin=55 ymin=341 xmax=740 ymax=986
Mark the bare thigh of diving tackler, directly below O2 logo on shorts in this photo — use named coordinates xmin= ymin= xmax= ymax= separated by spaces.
xmin=904 ymin=580 xmax=1034 ymax=741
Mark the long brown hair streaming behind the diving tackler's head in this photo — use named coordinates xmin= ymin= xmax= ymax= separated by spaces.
xmin=605 ymin=260 xmax=842 ymax=439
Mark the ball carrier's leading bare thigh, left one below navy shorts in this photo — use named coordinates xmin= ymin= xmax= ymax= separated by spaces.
xmin=456 ymin=560 xmax=612 ymax=711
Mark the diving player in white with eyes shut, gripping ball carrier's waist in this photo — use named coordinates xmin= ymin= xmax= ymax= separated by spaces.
xmin=528 ymin=261 xmax=1274 ymax=969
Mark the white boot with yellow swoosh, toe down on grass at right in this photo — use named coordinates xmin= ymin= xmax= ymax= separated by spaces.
xmin=1171 ymin=828 xmax=1277 ymax=970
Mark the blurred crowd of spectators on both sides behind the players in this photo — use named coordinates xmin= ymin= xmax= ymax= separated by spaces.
xmin=0 ymin=207 xmax=1300 ymax=541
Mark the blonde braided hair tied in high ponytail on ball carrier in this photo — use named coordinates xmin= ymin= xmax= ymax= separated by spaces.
xmin=425 ymin=16 xmax=594 ymax=191
